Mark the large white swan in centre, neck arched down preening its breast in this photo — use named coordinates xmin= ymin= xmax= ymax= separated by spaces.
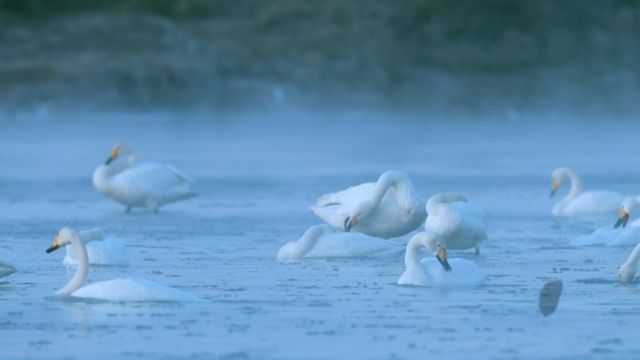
xmin=311 ymin=170 xmax=427 ymax=239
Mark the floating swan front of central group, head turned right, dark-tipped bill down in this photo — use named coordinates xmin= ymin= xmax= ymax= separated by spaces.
xmin=398 ymin=231 xmax=487 ymax=287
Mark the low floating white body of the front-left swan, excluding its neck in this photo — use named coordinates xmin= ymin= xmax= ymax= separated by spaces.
xmin=71 ymin=278 xmax=201 ymax=302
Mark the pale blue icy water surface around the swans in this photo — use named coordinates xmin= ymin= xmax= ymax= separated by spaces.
xmin=0 ymin=114 xmax=640 ymax=359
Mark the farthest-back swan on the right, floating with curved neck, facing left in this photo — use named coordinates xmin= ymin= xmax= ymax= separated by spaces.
xmin=550 ymin=167 xmax=624 ymax=216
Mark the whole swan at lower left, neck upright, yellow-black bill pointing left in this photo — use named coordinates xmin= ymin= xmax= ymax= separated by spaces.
xmin=47 ymin=227 xmax=201 ymax=301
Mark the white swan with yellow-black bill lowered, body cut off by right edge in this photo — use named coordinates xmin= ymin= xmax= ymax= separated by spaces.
xmin=570 ymin=197 xmax=640 ymax=246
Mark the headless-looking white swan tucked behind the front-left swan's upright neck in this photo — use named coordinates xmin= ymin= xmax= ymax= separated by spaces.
xmin=62 ymin=229 xmax=129 ymax=266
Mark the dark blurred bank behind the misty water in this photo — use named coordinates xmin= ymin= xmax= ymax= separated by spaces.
xmin=0 ymin=0 xmax=640 ymax=114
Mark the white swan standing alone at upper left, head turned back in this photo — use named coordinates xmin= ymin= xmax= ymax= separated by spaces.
xmin=93 ymin=144 xmax=196 ymax=211
